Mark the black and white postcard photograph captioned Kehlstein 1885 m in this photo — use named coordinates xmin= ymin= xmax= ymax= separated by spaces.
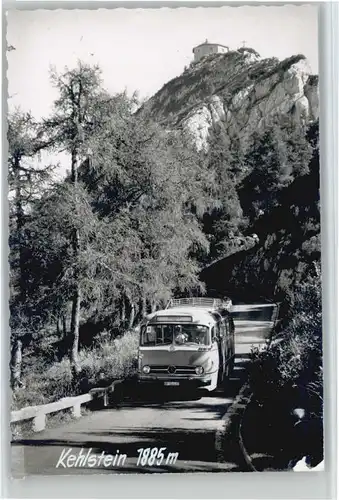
xmin=6 ymin=4 xmax=324 ymax=479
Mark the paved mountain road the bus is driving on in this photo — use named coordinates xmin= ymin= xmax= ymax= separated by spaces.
xmin=12 ymin=304 xmax=276 ymax=477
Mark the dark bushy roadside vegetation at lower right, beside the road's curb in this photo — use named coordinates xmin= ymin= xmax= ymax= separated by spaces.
xmin=249 ymin=273 xmax=323 ymax=467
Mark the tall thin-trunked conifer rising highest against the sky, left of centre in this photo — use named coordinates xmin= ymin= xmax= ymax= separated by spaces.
xmin=45 ymin=62 xmax=105 ymax=375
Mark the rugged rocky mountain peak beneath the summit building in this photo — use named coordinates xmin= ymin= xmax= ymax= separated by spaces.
xmin=142 ymin=48 xmax=319 ymax=148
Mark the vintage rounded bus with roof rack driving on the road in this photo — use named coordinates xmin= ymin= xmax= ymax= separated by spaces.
xmin=138 ymin=297 xmax=235 ymax=391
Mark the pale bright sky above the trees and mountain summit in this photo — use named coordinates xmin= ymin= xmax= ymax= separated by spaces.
xmin=7 ymin=5 xmax=318 ymax=119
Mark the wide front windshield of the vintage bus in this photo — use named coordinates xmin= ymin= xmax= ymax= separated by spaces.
xmin=141 ymin=324 xmax=209 ymax=346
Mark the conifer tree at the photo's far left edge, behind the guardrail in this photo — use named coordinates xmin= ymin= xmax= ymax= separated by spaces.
xmin=7 ymin=109 xmax=52 ymax=389
